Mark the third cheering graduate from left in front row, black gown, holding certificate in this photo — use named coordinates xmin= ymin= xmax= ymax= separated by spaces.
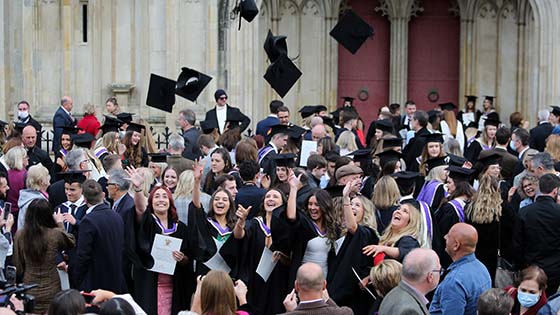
xmin=239 ymin=188 xmax=297 ymax=315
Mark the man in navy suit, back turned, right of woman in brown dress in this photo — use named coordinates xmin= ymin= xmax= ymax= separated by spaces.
xmin=70 ymin=179 xmax=126 ymax=293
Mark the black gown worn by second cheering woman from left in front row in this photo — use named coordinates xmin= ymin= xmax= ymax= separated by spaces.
xmin=188 ymin=202 xmax=242 ymax=279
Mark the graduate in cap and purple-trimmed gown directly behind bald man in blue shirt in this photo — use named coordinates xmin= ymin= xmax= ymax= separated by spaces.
xmin=433 ymin=165 xmax=475 ymax=268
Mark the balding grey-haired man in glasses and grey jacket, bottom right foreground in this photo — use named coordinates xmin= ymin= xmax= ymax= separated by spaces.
xmin=379 ymin=248 xmax=443 ymax=315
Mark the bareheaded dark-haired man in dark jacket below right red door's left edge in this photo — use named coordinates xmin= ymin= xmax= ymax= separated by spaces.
xmin=403 ymin=110 xmax=430 ymax=172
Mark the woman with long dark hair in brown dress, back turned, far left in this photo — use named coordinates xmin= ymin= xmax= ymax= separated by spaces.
xmin=14 ymin=199 xmax=75 ymax=314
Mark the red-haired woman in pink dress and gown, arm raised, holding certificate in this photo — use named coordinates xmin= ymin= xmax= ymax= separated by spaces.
xmin=126 ymin=167 xmax=191 ymax=315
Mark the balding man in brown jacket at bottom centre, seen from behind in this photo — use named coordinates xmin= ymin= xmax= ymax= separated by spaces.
xmin=284 ymin=263 xmax=354 ymax=315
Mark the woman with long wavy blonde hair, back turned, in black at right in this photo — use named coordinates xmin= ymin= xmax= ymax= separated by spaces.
xmin=465 ymin=175 xmax=514 ymax=280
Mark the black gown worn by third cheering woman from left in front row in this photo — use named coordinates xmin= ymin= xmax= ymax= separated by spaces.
xmin=239 ymin=207 xmax=290 ymax=315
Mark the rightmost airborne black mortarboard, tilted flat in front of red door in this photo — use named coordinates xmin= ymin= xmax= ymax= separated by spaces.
xmin=330 ymin=10 xmax=373 ymax=54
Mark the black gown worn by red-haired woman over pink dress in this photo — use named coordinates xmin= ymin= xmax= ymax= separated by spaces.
xmin=134 ymin=211 xmax=196 ymax=315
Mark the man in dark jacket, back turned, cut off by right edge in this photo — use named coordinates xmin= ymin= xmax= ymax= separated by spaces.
xmin=513 ymin=174 xmax=560 ymax=296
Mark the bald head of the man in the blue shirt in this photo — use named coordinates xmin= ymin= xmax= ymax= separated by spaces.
xmin=445 ymin=223 xmax=478 ymax=261
